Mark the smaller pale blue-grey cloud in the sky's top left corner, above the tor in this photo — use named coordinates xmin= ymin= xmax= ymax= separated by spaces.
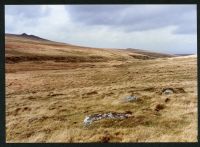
xmin=5 ymin=5 xmax=50 ymax=32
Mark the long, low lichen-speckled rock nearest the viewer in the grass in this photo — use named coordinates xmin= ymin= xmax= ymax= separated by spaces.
xmin=83 ymin=111 xmax=132 ymax=126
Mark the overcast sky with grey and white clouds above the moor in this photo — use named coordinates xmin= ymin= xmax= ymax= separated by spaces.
xmin=5 ymin=4 xmax=197 ymax=54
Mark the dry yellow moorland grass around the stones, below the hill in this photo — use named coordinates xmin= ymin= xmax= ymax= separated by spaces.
xmin=6 ymin=34 xmax=197 ymax=142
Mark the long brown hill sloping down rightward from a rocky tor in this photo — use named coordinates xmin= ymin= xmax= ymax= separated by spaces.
xmin=5 ymin=33 xmax=175 ymax=63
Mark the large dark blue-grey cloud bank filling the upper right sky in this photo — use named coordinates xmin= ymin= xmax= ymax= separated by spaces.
xmin=66 ymin=5 xmax=196 ymax=33
